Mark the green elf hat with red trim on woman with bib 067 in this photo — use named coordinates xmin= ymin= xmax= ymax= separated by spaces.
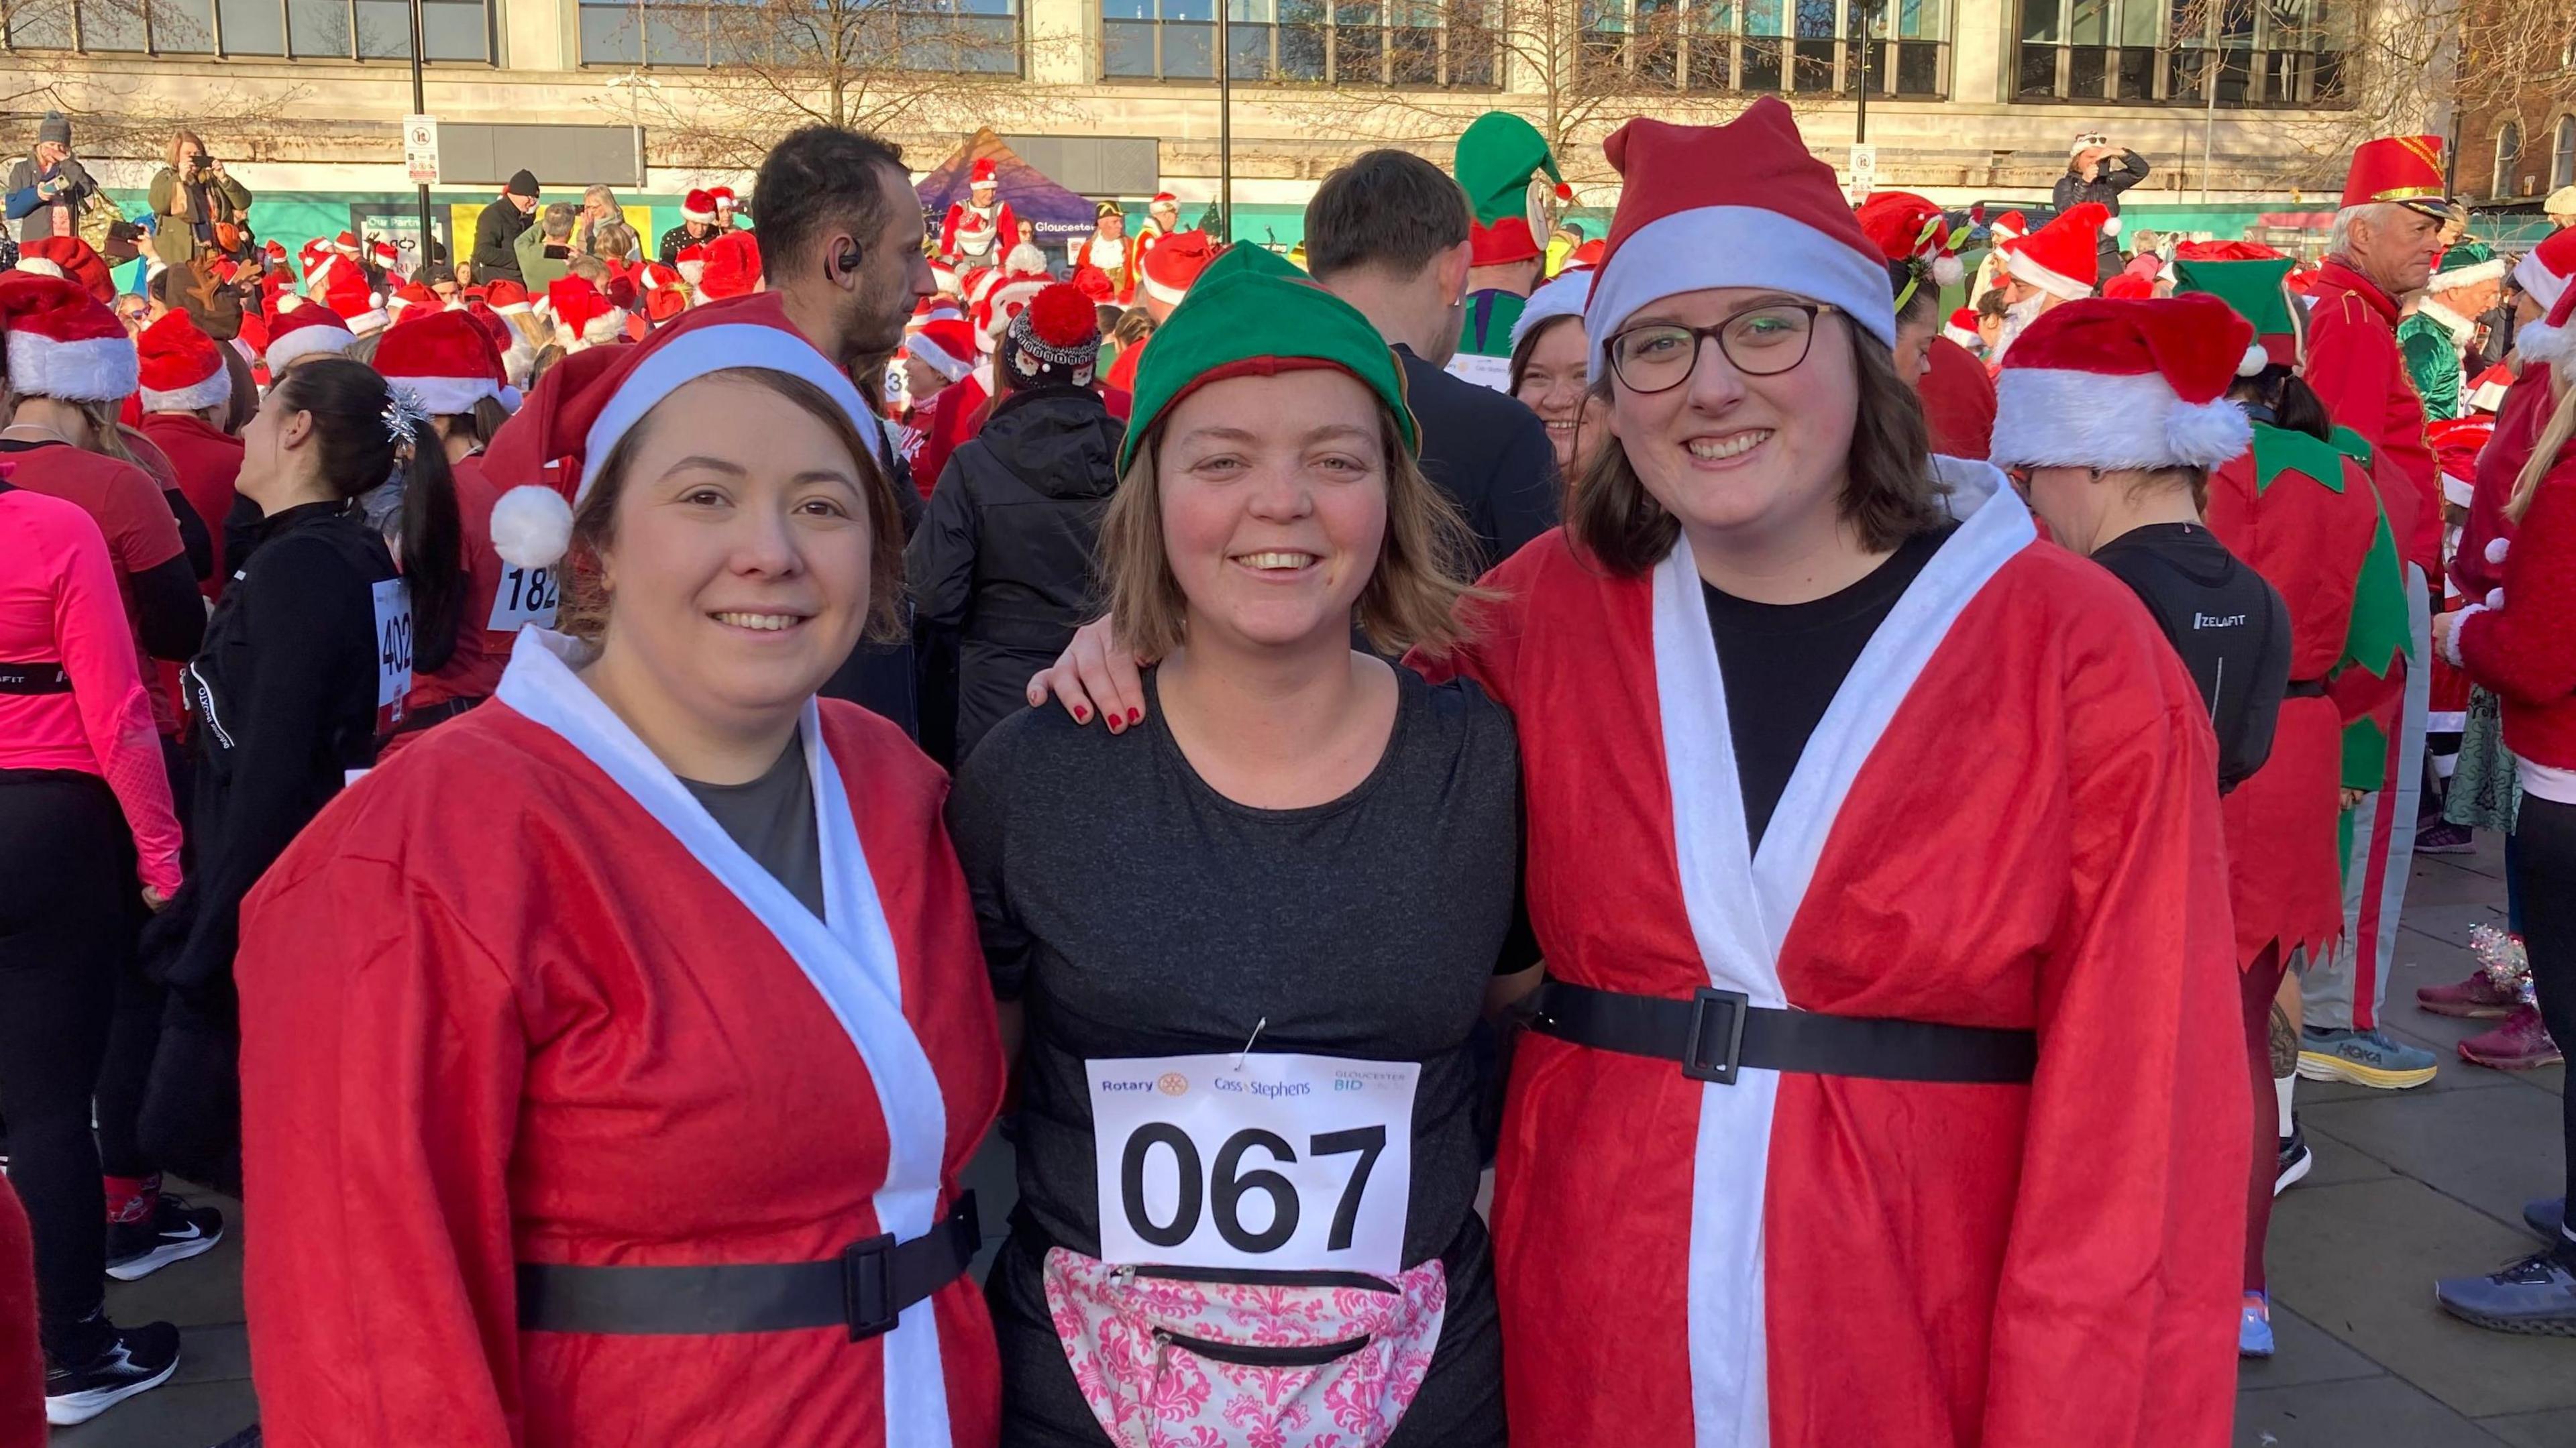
xmin=1118 ymin=245 xmax=1422 ymax=471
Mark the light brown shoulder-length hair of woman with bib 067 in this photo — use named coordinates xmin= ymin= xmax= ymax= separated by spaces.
xmin=1100 ymin=386 xmax=1487 ymax=659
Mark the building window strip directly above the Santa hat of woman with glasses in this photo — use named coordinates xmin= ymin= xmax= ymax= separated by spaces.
xmin=1579 ymin=0 xmax=1950 ymax=98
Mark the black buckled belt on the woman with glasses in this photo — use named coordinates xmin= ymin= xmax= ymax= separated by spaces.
xmin=1533 ymin=982 xmax=2040 ymax=1084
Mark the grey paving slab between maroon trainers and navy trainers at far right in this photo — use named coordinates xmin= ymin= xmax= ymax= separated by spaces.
xmin=2300 ymin=1066 xmax=2566 ymax=1227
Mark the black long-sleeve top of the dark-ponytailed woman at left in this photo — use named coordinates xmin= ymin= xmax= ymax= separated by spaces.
xmin=168 ymin=502 xmax=396 ymax=1000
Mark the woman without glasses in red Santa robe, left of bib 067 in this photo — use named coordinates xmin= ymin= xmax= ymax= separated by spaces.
xmin=237 ymin=319 xmax=1002 ymax=1448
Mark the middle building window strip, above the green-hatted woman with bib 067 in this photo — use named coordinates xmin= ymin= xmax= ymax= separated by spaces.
xmin=1100 ymin=0 xmax=1502 ymax=90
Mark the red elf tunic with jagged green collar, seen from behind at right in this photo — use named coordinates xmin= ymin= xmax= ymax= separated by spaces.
xmin=2205 ymin=423 xmax=2380 ymax=966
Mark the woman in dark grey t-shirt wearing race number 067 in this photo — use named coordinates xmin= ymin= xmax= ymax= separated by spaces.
xmin=948 ymin=247 xmax=1538 ymax=1448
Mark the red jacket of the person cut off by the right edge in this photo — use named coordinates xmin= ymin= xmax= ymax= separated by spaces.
xmin=2457 ymin=451 xmax=2576 ymax=771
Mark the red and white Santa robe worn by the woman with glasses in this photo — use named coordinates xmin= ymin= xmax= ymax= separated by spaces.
xmin=1460 ymin=461 xmax=2251 ymax=1448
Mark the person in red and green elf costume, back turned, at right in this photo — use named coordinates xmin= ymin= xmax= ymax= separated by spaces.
xmin=2174 ymin=258 xmax=2406 ymax=1358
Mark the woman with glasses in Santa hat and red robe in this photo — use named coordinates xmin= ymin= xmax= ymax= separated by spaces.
xmin=1046 ymin=98 xmax=2246 ymax=1448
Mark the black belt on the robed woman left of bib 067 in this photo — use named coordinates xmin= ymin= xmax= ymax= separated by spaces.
xmin=518 ymin=1193 xmax=981 ymax=1342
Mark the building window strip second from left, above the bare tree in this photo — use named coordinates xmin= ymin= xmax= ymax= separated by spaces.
xmin=577 ymin=0 xmax=1020 ymax=74
